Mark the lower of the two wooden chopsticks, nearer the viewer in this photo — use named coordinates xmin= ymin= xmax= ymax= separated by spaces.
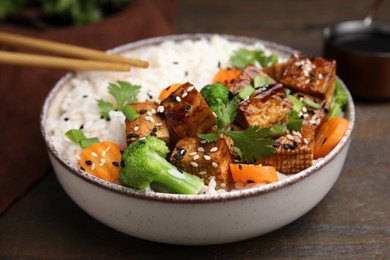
xmin=0 ymin=51 xmax=130 ymax=71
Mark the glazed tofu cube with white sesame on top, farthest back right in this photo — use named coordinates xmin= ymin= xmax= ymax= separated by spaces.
xmin=280 ymin=54 xmax=336 ymax=103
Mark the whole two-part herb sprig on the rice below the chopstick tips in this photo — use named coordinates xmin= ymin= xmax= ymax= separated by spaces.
xmin=96 ymin=80 xmax=141 ymax=119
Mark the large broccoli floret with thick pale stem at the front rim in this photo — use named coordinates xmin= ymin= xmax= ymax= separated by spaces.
xmin=119 ymin=136 xmax=204 ymax=194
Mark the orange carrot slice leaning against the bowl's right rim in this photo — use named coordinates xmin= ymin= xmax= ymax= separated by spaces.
xmin=314 ymin=117 xmax=349 ymax=159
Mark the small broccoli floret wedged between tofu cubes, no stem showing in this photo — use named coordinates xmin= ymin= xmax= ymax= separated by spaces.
xmin=200 ymin=82 xmax=229 ymax=112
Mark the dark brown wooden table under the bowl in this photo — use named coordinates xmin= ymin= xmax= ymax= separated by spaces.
xmin=0 ymin=0 xmax=390 ymax=259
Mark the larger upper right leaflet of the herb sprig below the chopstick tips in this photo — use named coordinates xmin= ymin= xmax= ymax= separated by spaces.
xmin=108 ymin=80 xmax=141 ymax=111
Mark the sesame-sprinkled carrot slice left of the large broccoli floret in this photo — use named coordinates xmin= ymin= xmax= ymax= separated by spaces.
xmin=80 ymin=141 xmax=122 ymax=182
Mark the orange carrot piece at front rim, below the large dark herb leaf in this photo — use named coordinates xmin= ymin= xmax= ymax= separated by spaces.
xmin=229 ymin=163 xmax=278 ymax=183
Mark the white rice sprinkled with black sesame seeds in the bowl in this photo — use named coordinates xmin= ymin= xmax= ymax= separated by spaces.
xmin=47 ymin=35 xmax=288 ymax=193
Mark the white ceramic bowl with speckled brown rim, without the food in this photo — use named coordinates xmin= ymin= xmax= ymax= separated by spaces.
xmin=41 ymin=34 xmax=355 ymax=245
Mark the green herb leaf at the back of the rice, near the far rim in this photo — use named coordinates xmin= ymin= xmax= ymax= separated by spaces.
xmin=230 ymin=48 xmax=278 ymax=69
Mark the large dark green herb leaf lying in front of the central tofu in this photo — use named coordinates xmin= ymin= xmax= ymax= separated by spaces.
xmin=222 ymin=126 xmax=274 ymax=162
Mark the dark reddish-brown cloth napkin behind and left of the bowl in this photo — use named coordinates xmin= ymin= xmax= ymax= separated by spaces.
xmin=0 ymin=0 xmax=177 ymax=214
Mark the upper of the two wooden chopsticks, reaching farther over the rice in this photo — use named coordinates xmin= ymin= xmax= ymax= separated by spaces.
xmin=0 ymin=32 xmax=149 ymax=71
